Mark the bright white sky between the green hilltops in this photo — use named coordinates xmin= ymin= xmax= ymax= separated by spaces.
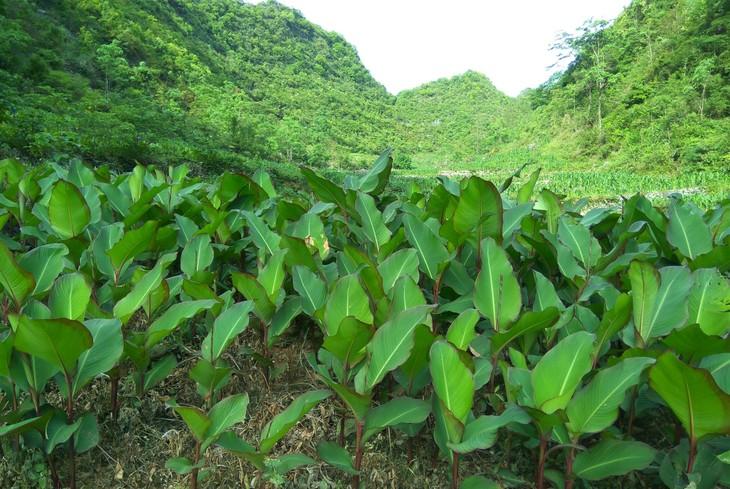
xmin=258 ymin=0 xmax=630 ymax=95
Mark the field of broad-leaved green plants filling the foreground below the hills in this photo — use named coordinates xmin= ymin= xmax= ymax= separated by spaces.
xmin=0 ymin=151 xmax=730 ymax=489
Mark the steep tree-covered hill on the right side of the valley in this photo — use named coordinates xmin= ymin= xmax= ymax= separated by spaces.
xmin=515 ymin=0 xmax=730 ymax=171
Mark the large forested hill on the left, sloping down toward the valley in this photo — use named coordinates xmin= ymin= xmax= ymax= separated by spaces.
xmin=0 ymin=0 xmax=393 ymax=167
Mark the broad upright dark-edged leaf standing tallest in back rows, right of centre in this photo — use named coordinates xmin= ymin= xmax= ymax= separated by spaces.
xmin=453 ymin=176 xmax=503 ymax=242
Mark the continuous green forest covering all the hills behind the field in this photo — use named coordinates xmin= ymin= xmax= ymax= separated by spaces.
xmin=0 ymin=0 xmax=730 ymax=172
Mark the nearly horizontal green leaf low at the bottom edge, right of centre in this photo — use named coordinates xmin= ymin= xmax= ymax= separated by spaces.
xmin=573 ymin=439 xmax=656 ymax=481
